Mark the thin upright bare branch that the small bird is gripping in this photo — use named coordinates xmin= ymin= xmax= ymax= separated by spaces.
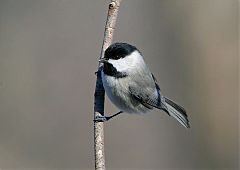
xmin=94 ymin=0 xmax=121 ymax=170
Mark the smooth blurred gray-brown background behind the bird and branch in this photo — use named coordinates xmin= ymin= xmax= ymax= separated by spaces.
xmin=0 ymin=0 xmax=239 ymax=170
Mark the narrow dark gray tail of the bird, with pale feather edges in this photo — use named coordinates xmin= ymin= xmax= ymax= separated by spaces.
xmin=164 ymin=97 xmax=190 ymax=128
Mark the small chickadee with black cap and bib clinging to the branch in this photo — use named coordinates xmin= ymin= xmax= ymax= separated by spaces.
xmin=95 ymin=43 xmax=190 ymax=128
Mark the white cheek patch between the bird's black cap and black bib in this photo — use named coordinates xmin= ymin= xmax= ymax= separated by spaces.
xmin=108 ymin=51 xmax=144 ymax=72
